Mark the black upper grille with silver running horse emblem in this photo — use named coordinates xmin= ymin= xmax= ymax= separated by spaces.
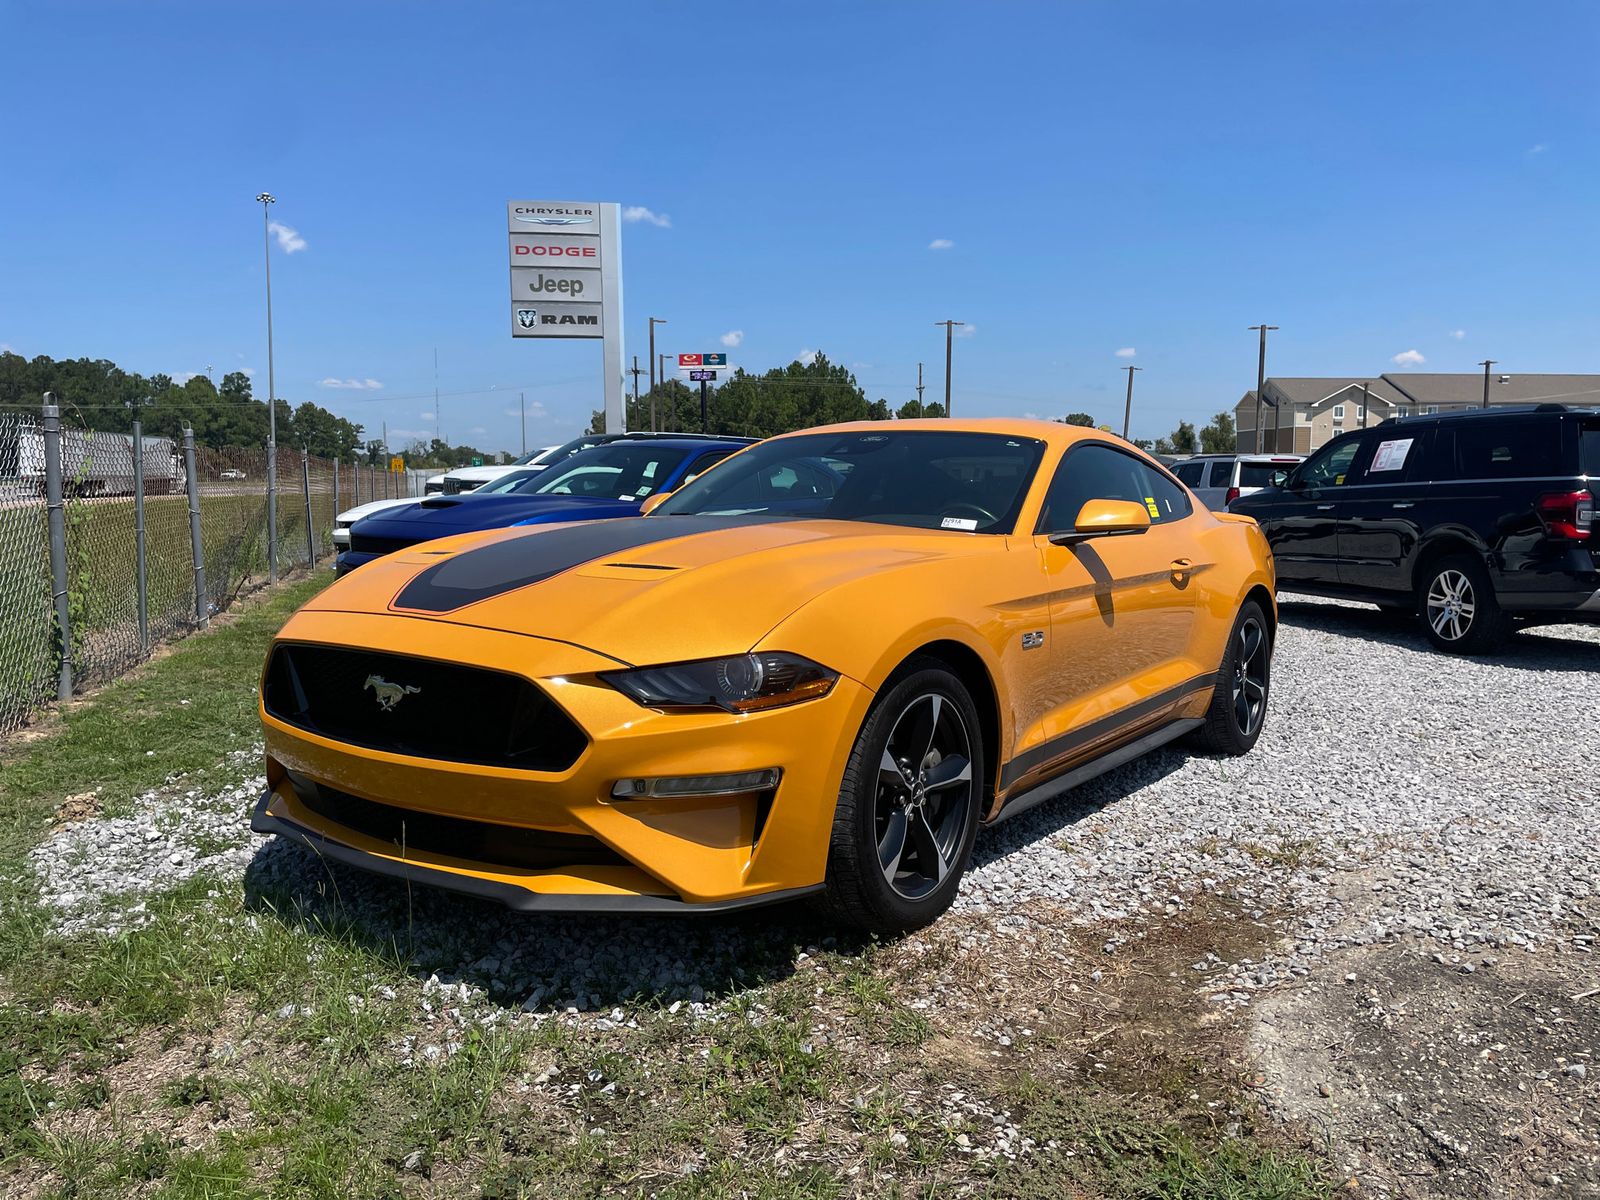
xmin=262 ymin=643 xmax=589 ymax=771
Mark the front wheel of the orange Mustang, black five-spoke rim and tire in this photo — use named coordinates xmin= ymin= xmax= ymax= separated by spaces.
xmin=818 ymin=658 xmax=986 ymax=934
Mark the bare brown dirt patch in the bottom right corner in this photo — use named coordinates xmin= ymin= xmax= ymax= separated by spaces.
xmin=1251 ymin=876 xmax=1600 ymax=1200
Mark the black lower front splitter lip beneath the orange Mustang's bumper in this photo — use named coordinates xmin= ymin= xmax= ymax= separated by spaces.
xmin=250 ymin=789 xmax=822 ymax=914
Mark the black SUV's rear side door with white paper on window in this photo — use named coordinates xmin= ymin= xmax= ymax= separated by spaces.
xmin=1338 ymin=426 xmax=1435 ymax=592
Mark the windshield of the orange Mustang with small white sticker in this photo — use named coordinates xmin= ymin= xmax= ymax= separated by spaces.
xmin=656 ymin=430 xmax=1045 ymax=533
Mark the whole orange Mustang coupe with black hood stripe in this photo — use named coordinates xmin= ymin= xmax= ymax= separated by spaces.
xmin=254 ymin=421 xmax=1275 ymax=931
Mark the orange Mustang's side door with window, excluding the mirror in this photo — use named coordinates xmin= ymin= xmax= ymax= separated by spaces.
xmin=1034 ymin=442 xmax=1210 ymax=738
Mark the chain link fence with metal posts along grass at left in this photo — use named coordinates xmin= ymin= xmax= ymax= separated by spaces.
xmin=0 ymin=408 xmax=437 ymax=733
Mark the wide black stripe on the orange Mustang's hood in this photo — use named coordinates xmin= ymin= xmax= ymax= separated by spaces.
xmin=394 ymin=514 xmax=782 ymax=613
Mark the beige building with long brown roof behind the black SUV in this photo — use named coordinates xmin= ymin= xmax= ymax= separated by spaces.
xmin=1234 ymin=371 xmax=1600 ymax=454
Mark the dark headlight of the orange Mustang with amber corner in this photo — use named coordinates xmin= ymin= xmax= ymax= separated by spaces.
xmin=600 ymin=650 xmax=838 ymax=712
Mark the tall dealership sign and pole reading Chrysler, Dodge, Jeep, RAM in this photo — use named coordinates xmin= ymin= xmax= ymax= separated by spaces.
xmin=506 ymin=200 xmax=626 ymax=434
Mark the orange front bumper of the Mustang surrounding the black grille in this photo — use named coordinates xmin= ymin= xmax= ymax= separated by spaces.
xmin=253 ymin=611 xmax=872 ymax=912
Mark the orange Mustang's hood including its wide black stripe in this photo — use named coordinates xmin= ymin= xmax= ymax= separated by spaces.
xmin=296 ymin=517 xmax=989 ymax=664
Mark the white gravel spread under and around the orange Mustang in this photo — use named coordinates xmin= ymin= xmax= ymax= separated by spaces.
xmin=21 ymin=597 xmax=1600 ymax=1019
